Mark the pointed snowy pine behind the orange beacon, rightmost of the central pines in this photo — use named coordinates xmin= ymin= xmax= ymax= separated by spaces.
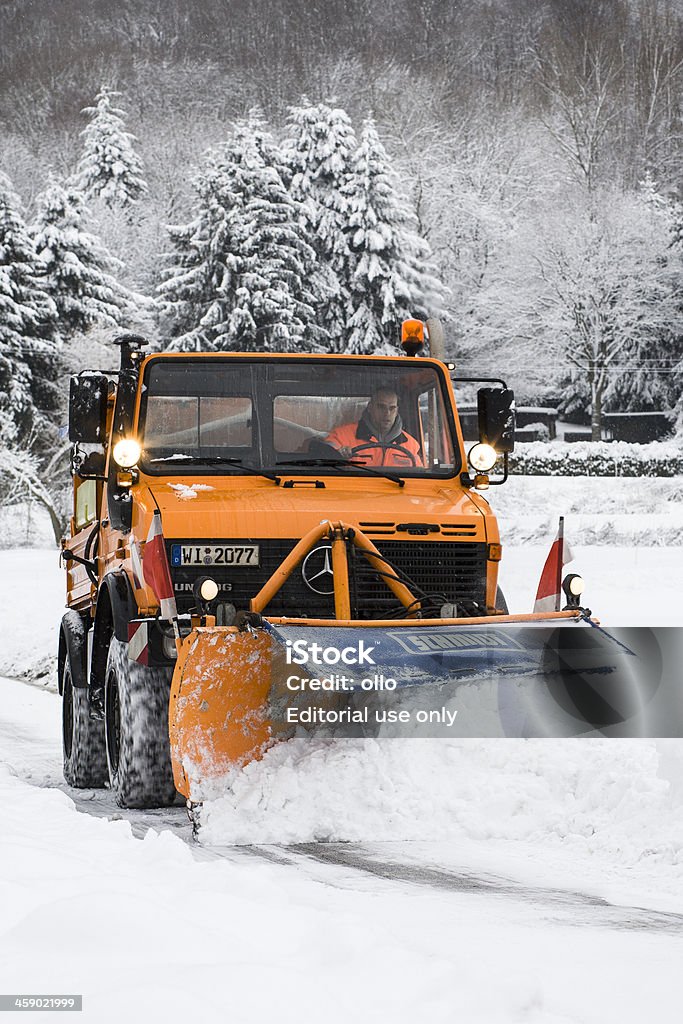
xmin=343 ymin=118 xmax=444 ymax=353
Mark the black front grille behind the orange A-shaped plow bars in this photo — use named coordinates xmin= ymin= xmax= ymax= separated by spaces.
xmin=167 ymin=538 xmax=486 ymax=618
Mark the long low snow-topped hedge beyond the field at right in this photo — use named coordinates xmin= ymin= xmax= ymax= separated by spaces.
xmin=510 ymin=441 xmax=683 ymax=476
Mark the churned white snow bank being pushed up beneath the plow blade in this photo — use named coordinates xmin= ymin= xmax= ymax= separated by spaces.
xmin=201 ymin=739 xmax=683 ymax=864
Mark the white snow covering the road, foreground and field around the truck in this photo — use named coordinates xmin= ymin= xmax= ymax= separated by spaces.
xmin=0 ymin=478 xmax=683 ymax=1024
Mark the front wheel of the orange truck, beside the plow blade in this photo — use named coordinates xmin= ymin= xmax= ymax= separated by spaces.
xmin=104 ymin=637 xmax=175 ymax=807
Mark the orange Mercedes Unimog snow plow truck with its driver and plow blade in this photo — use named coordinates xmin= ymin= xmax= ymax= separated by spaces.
xmin=58 ymin=321 xmax=587 ymax=807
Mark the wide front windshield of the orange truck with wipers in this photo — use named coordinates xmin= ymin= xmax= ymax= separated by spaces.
xmin=139 ymin=356 xmax=460 ymax=477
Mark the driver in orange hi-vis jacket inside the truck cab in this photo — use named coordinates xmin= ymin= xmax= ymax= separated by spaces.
xmin=325 ymin=387 xmax=424 ymax=467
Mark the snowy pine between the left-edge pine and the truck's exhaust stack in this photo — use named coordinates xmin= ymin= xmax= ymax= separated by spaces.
xmin=31 ymin=177 xmax=128 ymax=341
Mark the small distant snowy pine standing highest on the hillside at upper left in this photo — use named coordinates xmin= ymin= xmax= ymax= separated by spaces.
xmin=76 ymin=86 xmax=147 ymax=207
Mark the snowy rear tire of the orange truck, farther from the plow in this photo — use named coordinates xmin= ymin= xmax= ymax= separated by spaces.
xmin=61 ymin=652 xmax=109 ymax=790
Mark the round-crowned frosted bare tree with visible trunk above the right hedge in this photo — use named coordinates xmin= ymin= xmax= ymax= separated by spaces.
xmin=489 ymin=188 xmax=683 ymax=440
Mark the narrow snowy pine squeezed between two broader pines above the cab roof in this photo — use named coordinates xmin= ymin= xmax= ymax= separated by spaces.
xmin=282 ymin=98 xmax=357 ymax=351
